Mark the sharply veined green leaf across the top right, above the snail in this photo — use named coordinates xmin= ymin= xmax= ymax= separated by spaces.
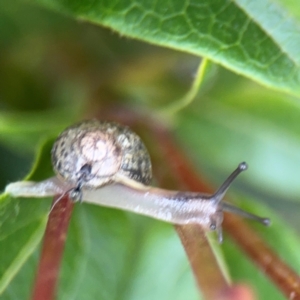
xmin=28 ymin=0 xmax=300 ymax=95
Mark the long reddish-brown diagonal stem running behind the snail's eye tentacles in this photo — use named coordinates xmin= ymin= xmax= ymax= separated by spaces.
xmin=155 ymin=130 xmax=300 ymax=299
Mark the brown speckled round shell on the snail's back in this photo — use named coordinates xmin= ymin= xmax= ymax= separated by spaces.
xmin=51 ymin=120 xmax=152 ymax=188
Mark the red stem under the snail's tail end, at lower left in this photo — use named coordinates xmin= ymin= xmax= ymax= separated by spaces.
xmin=31 ymin=195 xmax=74 ymax=300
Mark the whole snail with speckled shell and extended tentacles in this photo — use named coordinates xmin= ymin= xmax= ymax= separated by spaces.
xmin=5 ymin=120 xmax=270 ymax=242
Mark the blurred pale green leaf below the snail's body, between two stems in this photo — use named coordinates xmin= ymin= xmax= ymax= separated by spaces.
xmin=59 ymin=210 xmax=198 ymax=300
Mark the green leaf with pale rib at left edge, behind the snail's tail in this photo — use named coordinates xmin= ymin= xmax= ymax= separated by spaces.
xmin=0 ymin=141 xmax=53 ymax=294
